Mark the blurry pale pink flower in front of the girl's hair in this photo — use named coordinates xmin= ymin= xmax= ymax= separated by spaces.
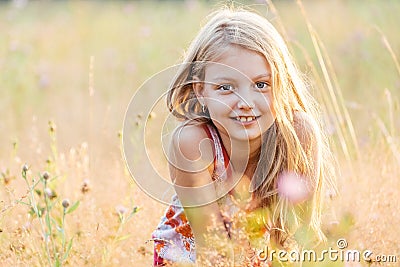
xmin=278 ymin=172 xmax=311 ymax=204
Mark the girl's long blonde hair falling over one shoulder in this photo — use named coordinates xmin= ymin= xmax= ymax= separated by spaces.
xmin=167 ymin=9 xmax=333 ymax=247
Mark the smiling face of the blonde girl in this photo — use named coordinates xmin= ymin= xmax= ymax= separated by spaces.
xmin=198 ymin=45 xmax=275 ymax=141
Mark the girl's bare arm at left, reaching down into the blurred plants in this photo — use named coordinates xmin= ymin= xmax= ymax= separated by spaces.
xmin=169 ymin=125 xmax=229 ymax=258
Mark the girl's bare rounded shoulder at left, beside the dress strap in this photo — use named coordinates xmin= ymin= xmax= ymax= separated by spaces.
xmin=170 ymin=124 xmax=213 ymax=176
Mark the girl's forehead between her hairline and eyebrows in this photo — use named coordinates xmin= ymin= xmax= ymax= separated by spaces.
xmin=205 ymin=46 xmax=271 ymax=80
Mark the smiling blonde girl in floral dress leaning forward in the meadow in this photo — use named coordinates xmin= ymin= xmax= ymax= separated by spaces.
xmin=153 ymin=9 xmax=330 ymax=266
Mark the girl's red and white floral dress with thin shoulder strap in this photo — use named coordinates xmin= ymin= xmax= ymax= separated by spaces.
xmin=152 ymin=124 xmax=229 ymax=266
